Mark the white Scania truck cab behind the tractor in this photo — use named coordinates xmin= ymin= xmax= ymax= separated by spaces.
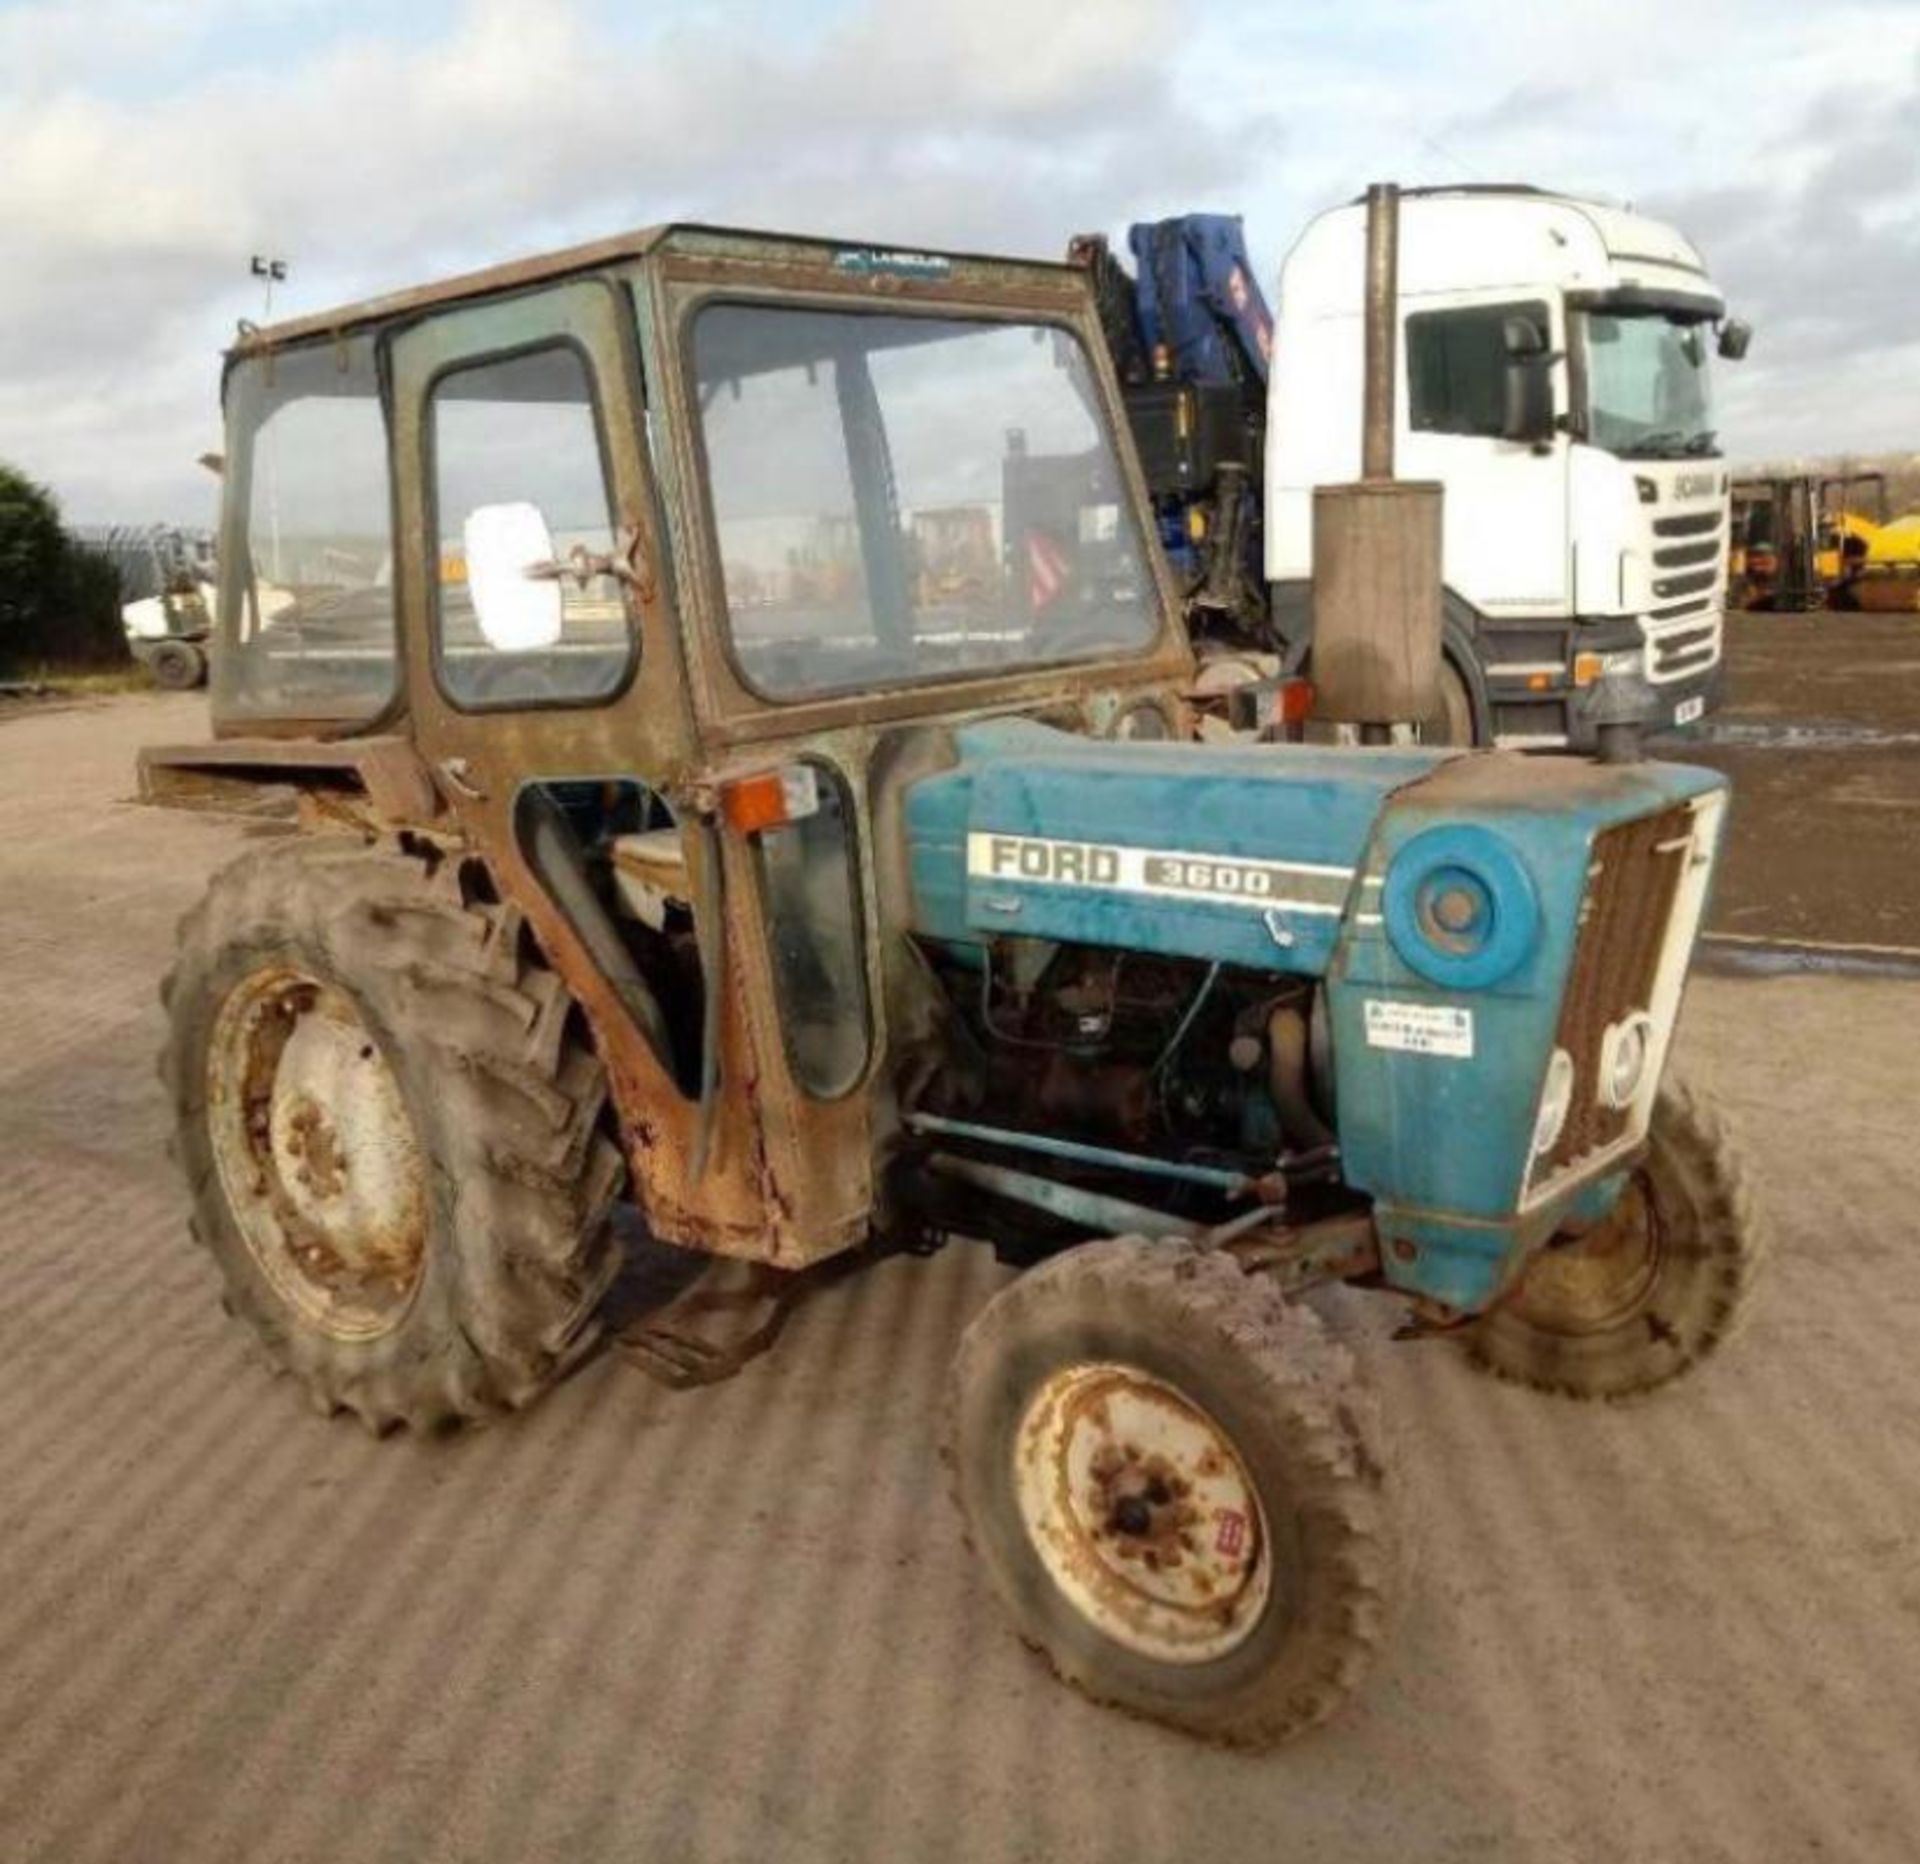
xmin=1265 ymin=186 xmax=1747 ymax=751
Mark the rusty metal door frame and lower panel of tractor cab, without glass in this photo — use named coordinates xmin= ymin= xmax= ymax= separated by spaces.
xmin=378 ymin=268 xmax=872 ymax=1267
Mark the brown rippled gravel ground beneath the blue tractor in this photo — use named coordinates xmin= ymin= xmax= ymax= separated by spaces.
xmin=0 ymin=699 xmax=1920 ymax=1864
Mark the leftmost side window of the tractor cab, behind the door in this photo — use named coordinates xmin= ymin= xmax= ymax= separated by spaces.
xmin=213 ymin=338 xmax=397 ymax=720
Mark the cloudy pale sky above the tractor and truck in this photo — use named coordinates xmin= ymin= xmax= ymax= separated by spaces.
xmin=0 ymin=0 xmax=1920 ymax=522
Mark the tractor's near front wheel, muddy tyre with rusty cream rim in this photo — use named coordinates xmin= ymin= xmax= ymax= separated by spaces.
xmin=947 ymin=1238 xmax=1400 ymax=1747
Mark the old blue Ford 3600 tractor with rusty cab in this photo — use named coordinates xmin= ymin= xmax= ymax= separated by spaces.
xmin=142 ymin=215 xmax=1755 ymax=1743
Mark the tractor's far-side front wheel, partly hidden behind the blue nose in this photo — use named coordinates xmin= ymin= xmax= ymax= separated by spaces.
xmin=1463 ymin=1083 xmax=1764 ymax=1398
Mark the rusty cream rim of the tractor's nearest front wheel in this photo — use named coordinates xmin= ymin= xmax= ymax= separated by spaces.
xmin=1014 ymin=1365 xmax=1273 ymax=1664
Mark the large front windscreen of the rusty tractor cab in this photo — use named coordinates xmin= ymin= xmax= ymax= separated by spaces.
xmin=693 ymin=303 xmax=1160 ymax=699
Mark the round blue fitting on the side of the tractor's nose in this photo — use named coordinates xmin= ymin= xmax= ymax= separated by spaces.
xmin=1382 ymin=824 xmax=1540 ymax=991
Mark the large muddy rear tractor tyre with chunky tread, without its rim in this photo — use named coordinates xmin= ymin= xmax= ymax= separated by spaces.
xmin=161 ymin=835 xmax=626 ymax=1434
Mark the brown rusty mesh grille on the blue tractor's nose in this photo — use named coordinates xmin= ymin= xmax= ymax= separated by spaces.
xmin=1528 ymin=804 xmax=1693 ymax=1186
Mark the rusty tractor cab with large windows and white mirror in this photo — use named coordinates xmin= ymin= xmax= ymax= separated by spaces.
xmin=146 ymin=228 xmax=1188 ymax=1265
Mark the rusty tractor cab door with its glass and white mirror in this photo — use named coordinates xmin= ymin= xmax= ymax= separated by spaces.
xmin=384 ymin=276 xmax=860 ymax=1259
